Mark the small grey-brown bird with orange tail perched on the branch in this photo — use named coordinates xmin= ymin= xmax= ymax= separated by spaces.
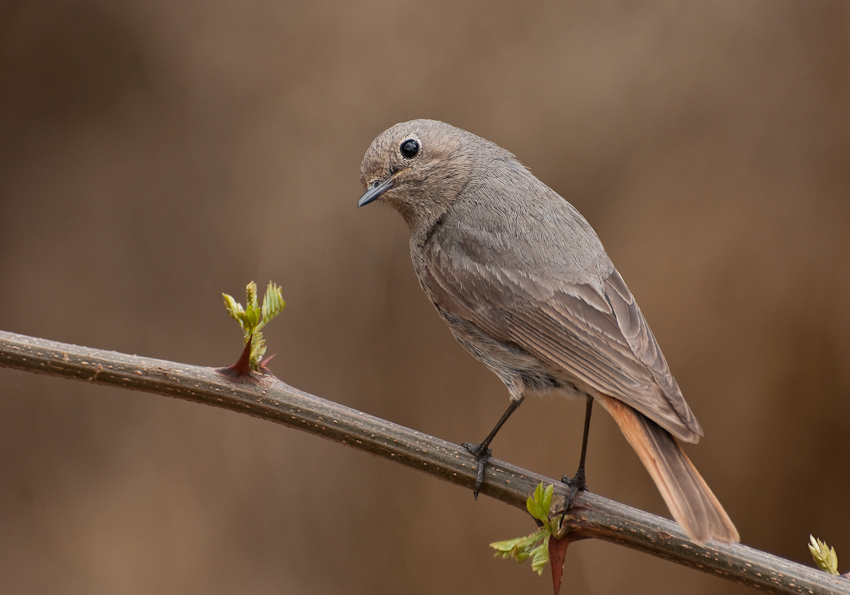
xmin=358 ymin=120 xmax=738 ymax=542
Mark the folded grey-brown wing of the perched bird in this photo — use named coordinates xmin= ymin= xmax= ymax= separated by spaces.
xmin=424 ymin=224 xmax=702 ymax=442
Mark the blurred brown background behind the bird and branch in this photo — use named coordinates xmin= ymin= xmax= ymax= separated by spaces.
xmin=0 ymin=0 xmax=850 ymax=594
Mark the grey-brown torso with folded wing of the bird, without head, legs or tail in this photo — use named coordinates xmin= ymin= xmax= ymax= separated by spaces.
xmin=411 ymin=162 xmax=702 ymax=442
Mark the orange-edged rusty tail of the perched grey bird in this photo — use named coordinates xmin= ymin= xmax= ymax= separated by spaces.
xmin=600 ymin=395 xmax=740 ymax=543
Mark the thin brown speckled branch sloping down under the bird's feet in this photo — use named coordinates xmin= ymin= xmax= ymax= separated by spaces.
xmin=0 ymin=331 xmax=850 ymax=595
